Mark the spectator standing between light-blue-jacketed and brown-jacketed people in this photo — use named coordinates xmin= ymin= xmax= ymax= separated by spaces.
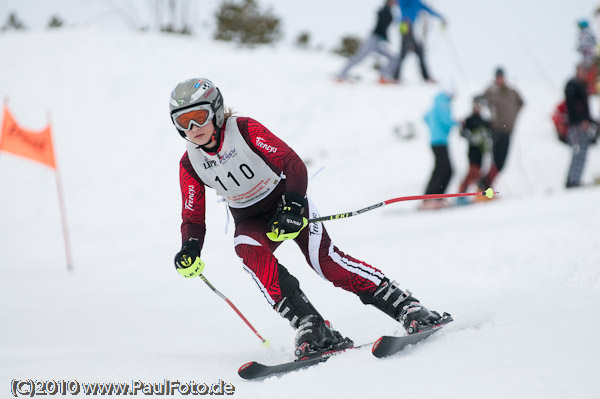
xmin=457 ymin=96 xmax=492 ymax=196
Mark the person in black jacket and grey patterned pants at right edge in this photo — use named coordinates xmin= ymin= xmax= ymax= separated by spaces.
xmin=565 ymin=64 xmax=593 ymax=188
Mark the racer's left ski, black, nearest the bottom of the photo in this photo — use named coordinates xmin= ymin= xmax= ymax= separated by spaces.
xmin=238 ymin=342 xmax=373 ymax=380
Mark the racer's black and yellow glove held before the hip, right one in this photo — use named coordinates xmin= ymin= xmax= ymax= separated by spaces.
xmin=267 ymin=192 xmax=308 ymax=241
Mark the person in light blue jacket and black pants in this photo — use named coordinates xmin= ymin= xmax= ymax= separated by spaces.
xmin=421 ymin=90 xmax=457 ymax=209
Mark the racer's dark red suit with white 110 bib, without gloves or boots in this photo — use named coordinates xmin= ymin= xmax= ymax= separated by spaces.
xmin=180 ymin=117 xmax=385 ymax=306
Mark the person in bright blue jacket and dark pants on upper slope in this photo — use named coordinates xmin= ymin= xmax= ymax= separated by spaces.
xmin=392 ymin=0 xmax=446 ymax=82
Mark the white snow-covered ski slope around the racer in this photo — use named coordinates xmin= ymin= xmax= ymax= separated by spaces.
xmin=0 ymin=30 xmax=600 ymax=398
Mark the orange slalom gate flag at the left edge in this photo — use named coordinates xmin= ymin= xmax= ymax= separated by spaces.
xmin=0 ymin=106 xmax=56 ymax=169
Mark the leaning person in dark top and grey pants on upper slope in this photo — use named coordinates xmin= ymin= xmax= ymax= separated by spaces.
xmin=337 ymin=0 xmax=396 ymax=82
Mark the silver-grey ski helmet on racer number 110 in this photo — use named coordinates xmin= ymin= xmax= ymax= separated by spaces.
xmin=169 ymin=78 xmax=225 ymax=138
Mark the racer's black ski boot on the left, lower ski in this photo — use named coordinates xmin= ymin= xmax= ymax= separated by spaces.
xmin=295 ymin=315 xmax=354 ymax=359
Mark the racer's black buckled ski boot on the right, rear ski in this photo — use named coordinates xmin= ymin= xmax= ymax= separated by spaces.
xmin=361 ymin=279 xmax=451 ymax=334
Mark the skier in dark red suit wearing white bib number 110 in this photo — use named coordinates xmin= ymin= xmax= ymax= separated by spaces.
xmin=169 ymin=78 xmax=448 ymax=358
